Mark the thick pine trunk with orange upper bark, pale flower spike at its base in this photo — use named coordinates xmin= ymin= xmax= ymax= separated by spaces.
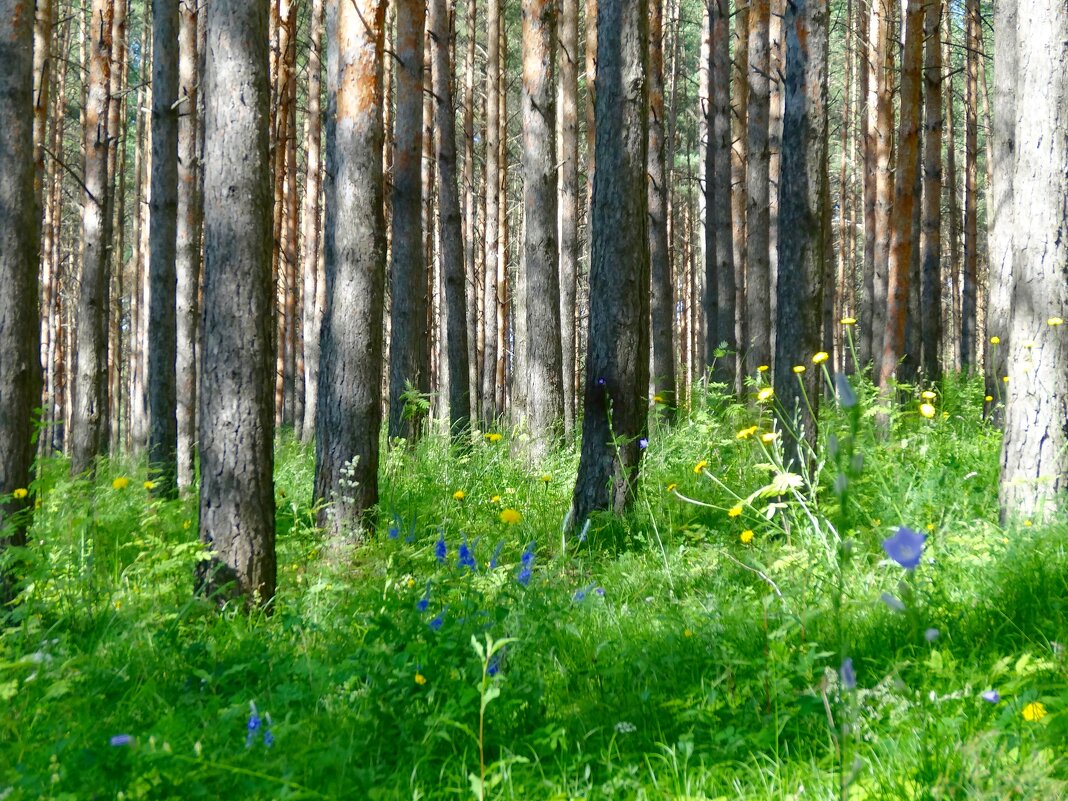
xmin=315 ymin=0 xmax=390 ymax=539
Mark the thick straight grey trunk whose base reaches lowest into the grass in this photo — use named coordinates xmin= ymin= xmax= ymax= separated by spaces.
xmin=198 ymin=0 xmax=277 ymax=607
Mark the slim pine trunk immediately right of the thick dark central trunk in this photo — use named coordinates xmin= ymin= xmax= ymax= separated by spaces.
xmin=648 ymin=0 xmax=670 ymax=423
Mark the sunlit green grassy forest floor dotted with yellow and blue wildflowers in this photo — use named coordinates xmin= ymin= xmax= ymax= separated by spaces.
xmin=0 ymin=379 xmax=1068 ymax=801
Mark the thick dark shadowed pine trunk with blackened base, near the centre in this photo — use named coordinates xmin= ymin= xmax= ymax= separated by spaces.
xmin=570 ymin=0 xmax=649 ymax=530
